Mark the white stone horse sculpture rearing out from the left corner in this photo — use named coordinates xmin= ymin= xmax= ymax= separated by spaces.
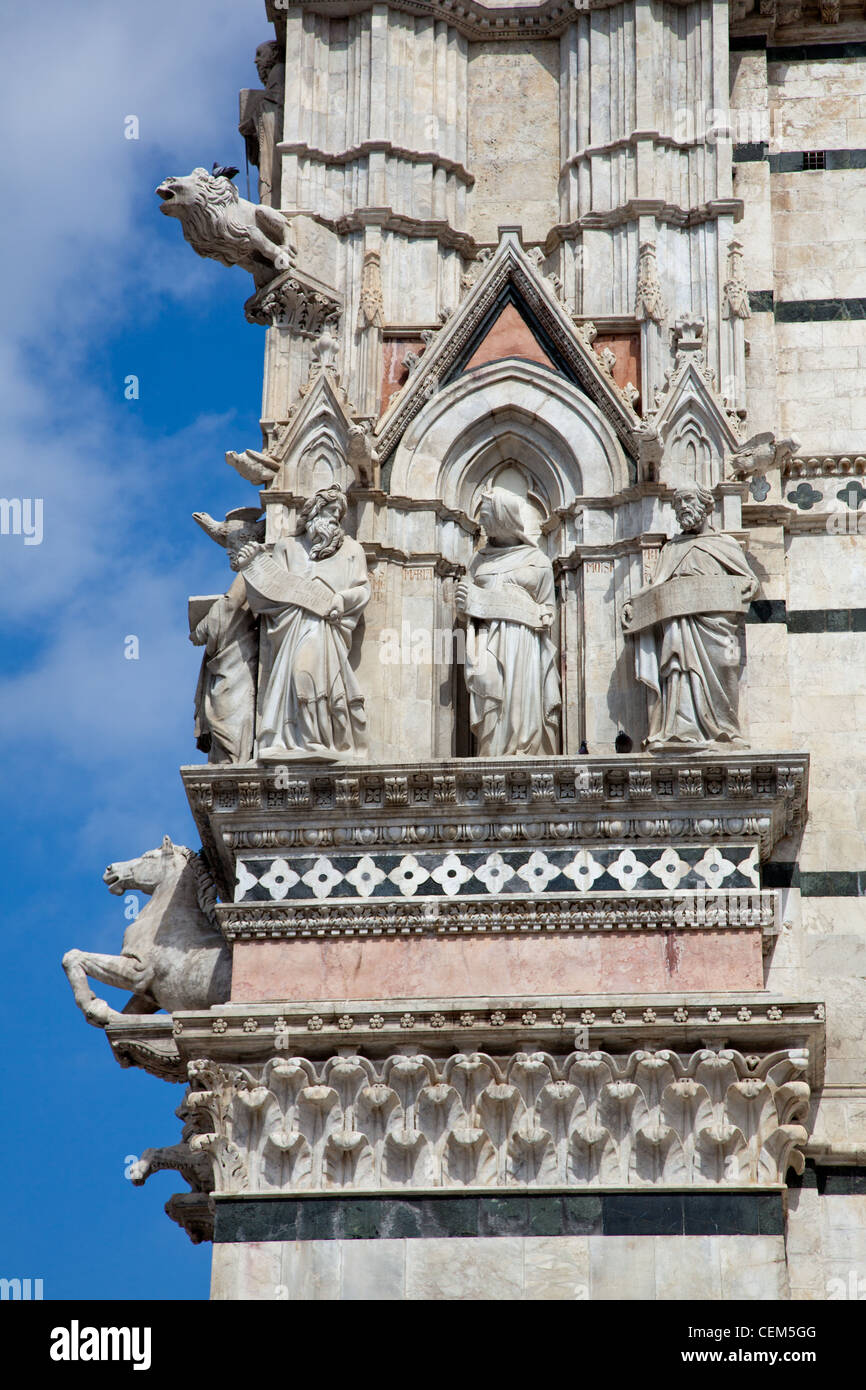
xmin=63 ymin=835 xmax=232 ymax=1029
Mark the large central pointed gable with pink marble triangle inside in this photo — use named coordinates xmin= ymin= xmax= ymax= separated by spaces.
xmin=375 ymin=232 xmax=641 ymax=463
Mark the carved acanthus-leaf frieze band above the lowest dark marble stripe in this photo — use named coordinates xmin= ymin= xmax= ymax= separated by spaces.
xmin=162 ymin=1048 xmax=810 ymax=1194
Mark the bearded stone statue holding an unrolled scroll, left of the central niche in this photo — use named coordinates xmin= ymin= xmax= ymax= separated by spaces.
xmin=234 ymin=487 xmax=371 ymax=762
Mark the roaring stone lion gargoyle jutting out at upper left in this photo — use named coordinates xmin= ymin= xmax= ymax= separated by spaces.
xmin=156 ymin=168 xmax=297 ymax=289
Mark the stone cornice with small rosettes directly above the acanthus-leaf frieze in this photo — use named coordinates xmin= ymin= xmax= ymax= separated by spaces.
xmin=107 ymin=991 xmax=826 ymax=1090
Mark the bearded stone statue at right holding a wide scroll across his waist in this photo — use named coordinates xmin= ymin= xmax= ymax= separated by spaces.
xmin=623 ymin=484 xmax=759 ymax=752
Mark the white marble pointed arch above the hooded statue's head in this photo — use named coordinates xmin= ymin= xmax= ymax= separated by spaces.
xmin=391 ymin=357 xmax=628 ymax=517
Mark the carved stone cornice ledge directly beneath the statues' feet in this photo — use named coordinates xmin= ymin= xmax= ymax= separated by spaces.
xmin=181 ymin=749 xmax=809 ymax=898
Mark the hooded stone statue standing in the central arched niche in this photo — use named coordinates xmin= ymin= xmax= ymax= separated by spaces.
xmin=456 ymin=488 xmax=560 ymax=758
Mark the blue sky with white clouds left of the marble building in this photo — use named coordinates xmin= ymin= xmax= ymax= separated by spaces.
xmin=0 ymin=0 xmax=272 ymax=1298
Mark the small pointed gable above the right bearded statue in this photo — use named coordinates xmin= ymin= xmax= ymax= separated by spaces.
xmin=655 ymin=354 xmax=740 ymax=488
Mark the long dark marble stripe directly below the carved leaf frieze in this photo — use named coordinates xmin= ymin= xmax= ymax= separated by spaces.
xmin=214 ymin=1188 xmax=784 ymax=1244
